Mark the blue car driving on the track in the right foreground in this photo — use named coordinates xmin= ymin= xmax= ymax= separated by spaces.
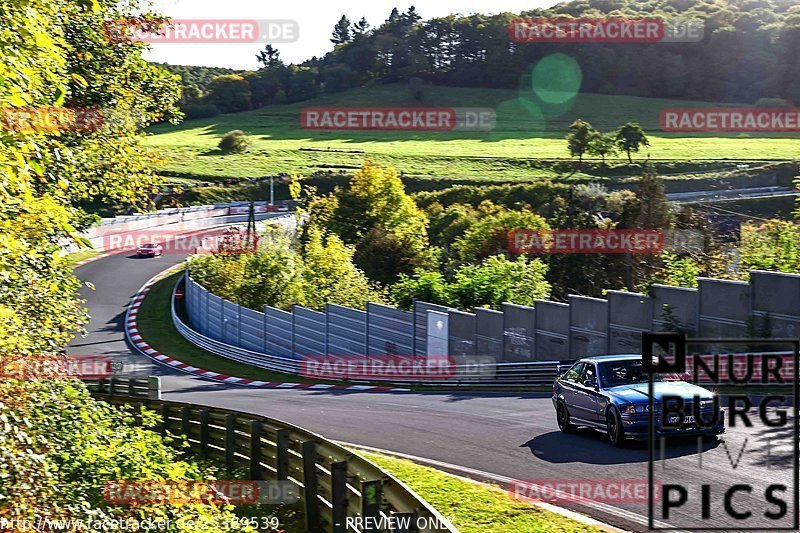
xmin=553 ymin=355 xmax=725 ymax=446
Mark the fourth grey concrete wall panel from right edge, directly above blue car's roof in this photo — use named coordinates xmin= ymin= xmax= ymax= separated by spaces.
xmin=606 ymin=291 xmax=653 ymax=354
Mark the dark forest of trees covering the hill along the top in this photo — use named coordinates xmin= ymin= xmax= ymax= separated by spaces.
xmin=171 ymin=0 xmax=800 ymax=116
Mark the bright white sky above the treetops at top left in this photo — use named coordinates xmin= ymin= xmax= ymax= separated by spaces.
xmin=146 ymin=0 xmax=557 ymax=69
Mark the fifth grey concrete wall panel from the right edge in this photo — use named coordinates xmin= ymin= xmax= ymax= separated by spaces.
xmin=569 ymin=295 xmax=608 ymax=359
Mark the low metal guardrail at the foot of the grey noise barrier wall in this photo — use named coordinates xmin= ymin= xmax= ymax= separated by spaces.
xmin=171 ymin=278 xmax=563 ymax=388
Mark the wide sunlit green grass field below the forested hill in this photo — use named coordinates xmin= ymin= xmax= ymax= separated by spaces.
xmin=146 ymin=84 xmax=800 ymax=180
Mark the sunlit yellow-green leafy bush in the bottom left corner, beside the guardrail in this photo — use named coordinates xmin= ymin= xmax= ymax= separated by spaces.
xmin=0 ymin=380 xmax=244 ymax=531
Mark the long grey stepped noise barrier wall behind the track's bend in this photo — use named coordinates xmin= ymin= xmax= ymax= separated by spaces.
xmin=185 ymin=271 xmax=800 ymax=363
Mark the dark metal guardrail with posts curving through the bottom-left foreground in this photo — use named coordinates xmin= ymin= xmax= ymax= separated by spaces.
xmin=90 ymin=388 xmax=458 ymax=533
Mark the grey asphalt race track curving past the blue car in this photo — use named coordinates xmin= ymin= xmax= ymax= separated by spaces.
xmin=69 ymin=250 xmax=796 ymax=531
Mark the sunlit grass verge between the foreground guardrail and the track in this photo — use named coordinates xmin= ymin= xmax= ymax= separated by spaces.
xmin=357 ymin=450 xmax=602 ymax=533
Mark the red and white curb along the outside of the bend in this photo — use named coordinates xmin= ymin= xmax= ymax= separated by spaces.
xmin=125 ymin=269 xmax=409 ymax=392
